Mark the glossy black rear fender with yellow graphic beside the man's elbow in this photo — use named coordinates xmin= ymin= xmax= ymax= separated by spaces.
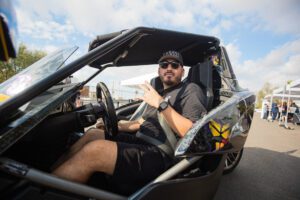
xmin=175 ymin=92 xmax=255 ymax=156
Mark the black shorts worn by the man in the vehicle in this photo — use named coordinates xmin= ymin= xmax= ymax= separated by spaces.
xmin=111 ymin=133 xmax=174 ymax=192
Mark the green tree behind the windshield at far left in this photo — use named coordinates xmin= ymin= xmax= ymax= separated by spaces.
xmin=0 ymin=44 xmax=46 ymax=83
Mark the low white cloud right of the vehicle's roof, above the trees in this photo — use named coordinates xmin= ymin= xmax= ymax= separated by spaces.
xmin=232 ymin=40 xmax=300 ymax=91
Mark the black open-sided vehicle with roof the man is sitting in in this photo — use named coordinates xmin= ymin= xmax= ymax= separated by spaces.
xmin=0 ymin=27 xmax=255 ymax=199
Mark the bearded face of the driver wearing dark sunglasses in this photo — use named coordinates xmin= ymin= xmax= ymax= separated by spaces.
xmin=158 ymin=59 xmax=184 ymax=87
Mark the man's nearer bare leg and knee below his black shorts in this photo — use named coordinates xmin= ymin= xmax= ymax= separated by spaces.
xmin=53 ymin=140 xmax=117 ymax=183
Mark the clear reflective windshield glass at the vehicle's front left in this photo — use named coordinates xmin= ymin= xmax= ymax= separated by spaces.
xmin=0 ymin=47 xmax=78 ymax=107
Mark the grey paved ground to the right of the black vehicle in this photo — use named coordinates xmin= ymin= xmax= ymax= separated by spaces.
xmin=215 ymin=113 xmax=300 ymax=200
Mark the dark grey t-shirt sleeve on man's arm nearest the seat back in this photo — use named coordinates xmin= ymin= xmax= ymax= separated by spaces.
xmin=180 ymin=84 xmax=207 ymax=122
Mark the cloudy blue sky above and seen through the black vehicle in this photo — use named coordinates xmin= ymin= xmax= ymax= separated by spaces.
xmin=15 ymin=0 xmax=300 ymax=96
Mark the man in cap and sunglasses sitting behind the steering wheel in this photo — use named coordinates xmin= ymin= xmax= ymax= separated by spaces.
xmin=53 ymin=51 xmax=206 ymax=191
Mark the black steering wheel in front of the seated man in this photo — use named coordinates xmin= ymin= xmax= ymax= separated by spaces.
xmin=96 ymin=82 xmax=118 ymax=136
